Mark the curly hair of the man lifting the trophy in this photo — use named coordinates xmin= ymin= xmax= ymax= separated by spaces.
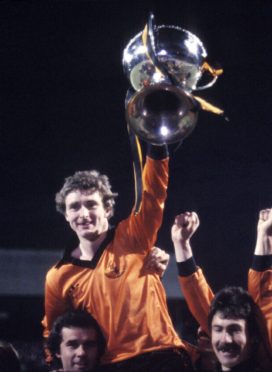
xmin=55 ymin=170 xmax=118 ymax=218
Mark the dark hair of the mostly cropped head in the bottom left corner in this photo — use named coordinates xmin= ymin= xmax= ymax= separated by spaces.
xmin=0 ymin=341 xmax=21 ymax=372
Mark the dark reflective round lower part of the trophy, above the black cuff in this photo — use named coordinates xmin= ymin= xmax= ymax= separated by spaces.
xmin=126 ymin=83 xmax=198 ymax=145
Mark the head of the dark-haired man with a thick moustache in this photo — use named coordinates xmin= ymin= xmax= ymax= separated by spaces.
xmin=209 ymin=287 xmax=262 ymax=371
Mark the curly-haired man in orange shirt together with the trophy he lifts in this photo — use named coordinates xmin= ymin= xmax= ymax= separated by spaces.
xmin=43 ymin=16 xmax=221 ymax=372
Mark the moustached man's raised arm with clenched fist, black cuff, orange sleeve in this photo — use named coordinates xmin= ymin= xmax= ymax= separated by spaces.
xmin=171 ymin=212 xmax=213 ymax=333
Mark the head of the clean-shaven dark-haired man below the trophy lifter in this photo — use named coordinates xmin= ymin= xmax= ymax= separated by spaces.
xmin=48 ymin=311 xmax=106 ymax=372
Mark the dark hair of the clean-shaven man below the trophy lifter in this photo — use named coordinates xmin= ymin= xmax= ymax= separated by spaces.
xmin=46 ymin=310 xmax=106 ymax=368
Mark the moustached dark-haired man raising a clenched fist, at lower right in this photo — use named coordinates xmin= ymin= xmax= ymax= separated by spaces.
xmin=171 ymin=212 xmax=272 ymax=371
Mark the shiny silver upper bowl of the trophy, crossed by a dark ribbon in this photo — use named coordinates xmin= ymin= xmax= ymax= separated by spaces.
xmin=123 ymin=25 xmax=207 ymax=92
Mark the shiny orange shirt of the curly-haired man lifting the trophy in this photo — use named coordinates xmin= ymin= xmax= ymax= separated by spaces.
xmin=43 ymin=158 xmax=193 ymax=363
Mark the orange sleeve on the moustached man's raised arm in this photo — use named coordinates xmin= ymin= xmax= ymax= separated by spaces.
xmin=178 ymin=268 xmax=214 ymax=334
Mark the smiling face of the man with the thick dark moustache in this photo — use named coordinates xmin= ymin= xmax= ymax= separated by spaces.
xmin=211 ymin=312 xmax=251 ymax=371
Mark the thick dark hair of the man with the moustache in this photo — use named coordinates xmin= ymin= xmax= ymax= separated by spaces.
xmin=208 ymin=287 xmax=272 ymax=367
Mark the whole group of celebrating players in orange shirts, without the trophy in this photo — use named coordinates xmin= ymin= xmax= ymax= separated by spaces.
xmin=0 ymin=145 xmax=272 ymax=372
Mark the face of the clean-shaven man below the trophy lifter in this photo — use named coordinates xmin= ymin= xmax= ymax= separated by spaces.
xmin=57 ymin=327 xmax=98 ymax=372
